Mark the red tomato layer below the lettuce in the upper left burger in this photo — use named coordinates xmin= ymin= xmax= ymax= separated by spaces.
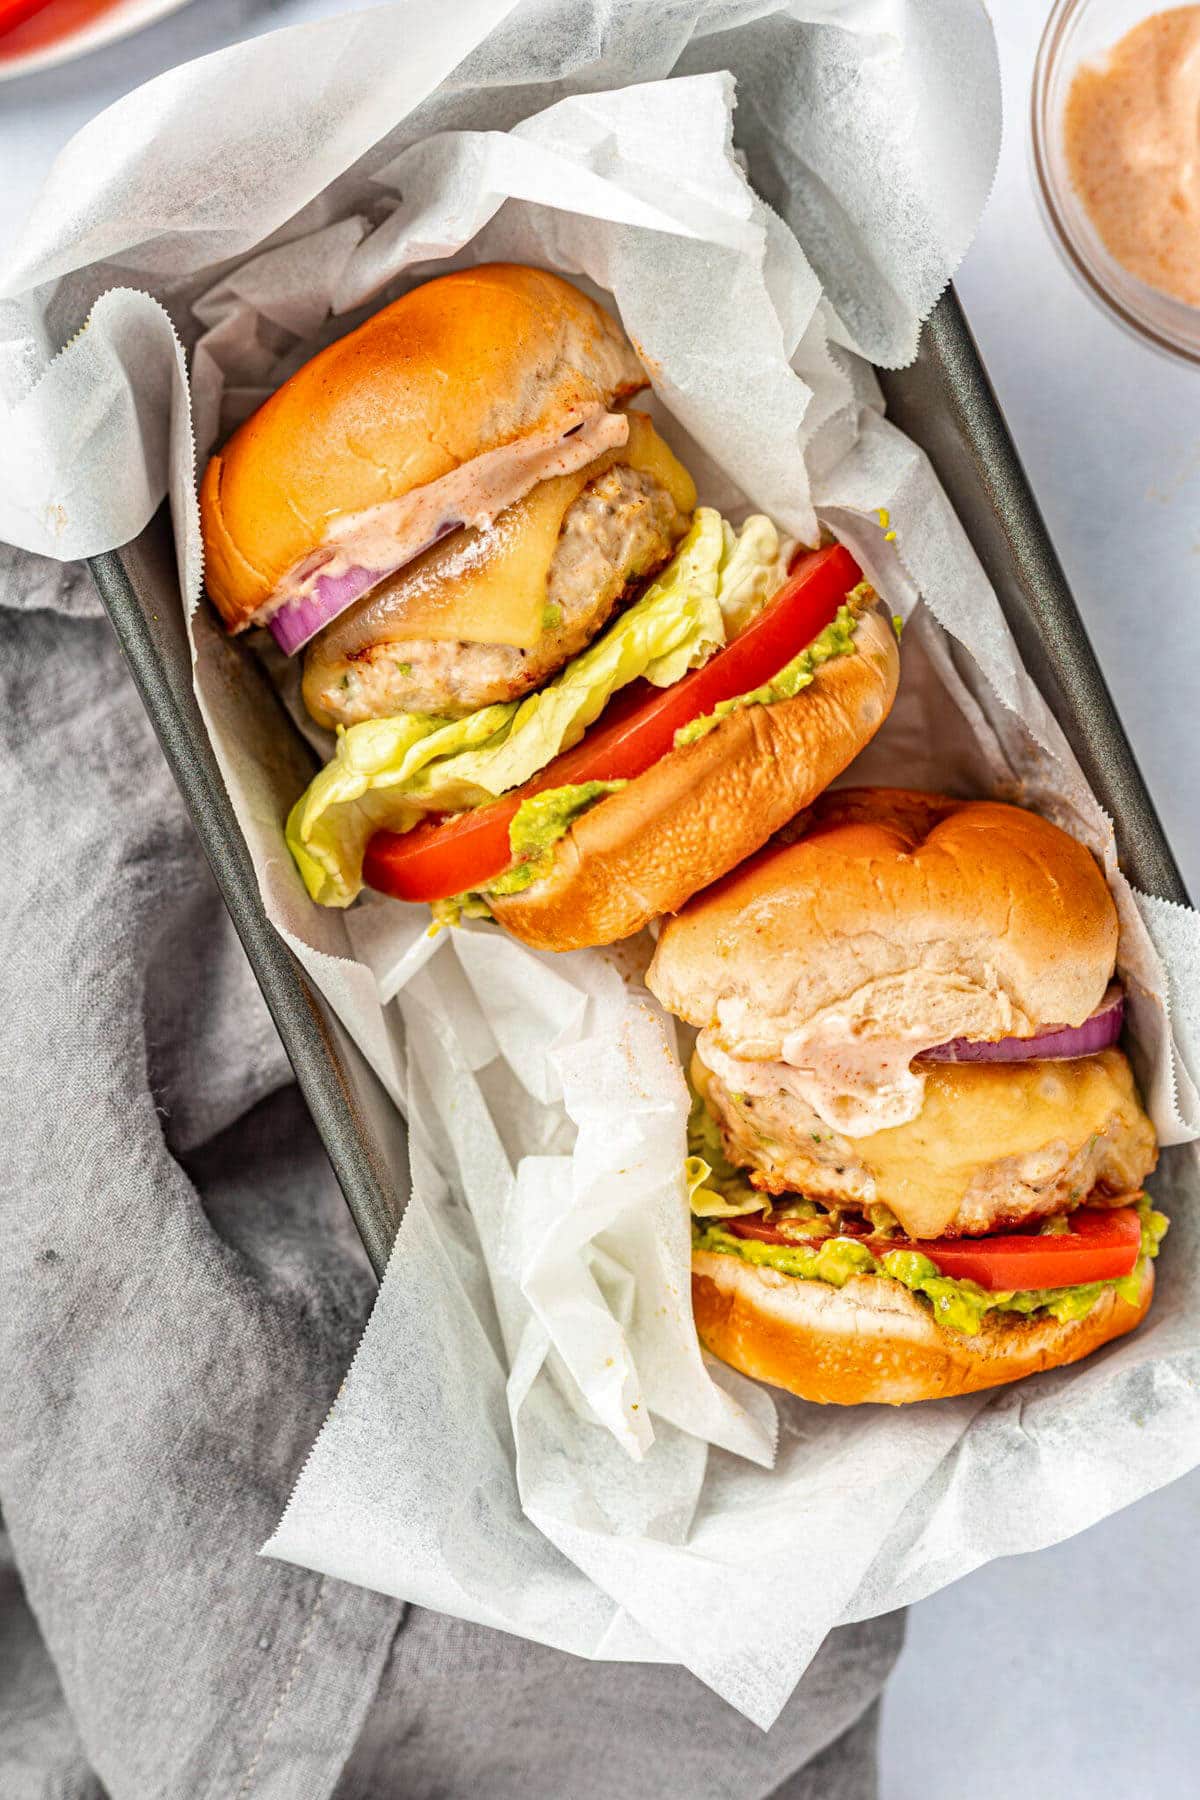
xmin=363 ymin=544 xmax=862 ymax=900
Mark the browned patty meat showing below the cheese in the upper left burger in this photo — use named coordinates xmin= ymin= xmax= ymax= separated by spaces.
xmin=304 ymin=464 xmax=689 ymax=725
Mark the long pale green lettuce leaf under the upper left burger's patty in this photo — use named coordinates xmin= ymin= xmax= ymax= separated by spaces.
xmin=286 ymin=506 xmax=779 ymax=905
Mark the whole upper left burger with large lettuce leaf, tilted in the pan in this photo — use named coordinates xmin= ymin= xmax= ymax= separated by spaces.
xmin=200 ymin=265 xmax=898 ymax=950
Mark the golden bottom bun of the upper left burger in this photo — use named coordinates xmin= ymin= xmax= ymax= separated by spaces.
xmin=489 ymin=608 xmax=900 ymax=950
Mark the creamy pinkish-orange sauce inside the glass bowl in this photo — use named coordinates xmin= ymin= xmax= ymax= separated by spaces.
xmin=1063 ymin=5 xmax=1200 ymax=306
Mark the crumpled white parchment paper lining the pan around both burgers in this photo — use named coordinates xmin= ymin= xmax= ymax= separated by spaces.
xmin=0 ymin=0 xmax=1200 ymax=1726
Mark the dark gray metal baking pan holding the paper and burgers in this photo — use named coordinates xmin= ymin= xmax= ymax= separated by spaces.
xmin=92 ymin=290 xmax=1187 ymax=1276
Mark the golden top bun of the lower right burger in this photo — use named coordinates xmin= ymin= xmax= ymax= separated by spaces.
xmin=646 ymin=788 xmax=1117 ymax=1060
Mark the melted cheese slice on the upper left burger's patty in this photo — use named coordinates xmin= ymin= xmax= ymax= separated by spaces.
xmin=356 ymin=412 xmax=696 ymax=650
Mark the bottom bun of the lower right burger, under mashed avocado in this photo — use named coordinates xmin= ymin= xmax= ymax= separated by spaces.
xmin=691 ymin=1251 xmax=1155 ymax=1406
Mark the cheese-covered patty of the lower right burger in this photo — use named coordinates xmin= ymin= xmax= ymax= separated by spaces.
xmin=693 ymin=1051 xmax=1157 ymax=1237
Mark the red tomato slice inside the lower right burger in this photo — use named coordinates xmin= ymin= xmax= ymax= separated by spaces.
xmin=729 ymin=1206 xmax=1142 ymax=1294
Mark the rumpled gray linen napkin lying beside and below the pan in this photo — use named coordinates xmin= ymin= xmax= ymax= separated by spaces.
xmin=0 ymin=545 xmax=901 ymax=1800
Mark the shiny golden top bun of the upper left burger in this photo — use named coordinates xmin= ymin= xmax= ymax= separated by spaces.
xmin=200 ymin=263 xmax=646 ymax=626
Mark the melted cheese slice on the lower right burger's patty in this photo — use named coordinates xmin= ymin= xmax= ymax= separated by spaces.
xmin=855 ymin=1049 xmax=1153 ymax=1238
